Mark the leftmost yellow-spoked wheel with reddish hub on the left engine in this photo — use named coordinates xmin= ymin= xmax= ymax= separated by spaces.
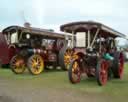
xmin=10 ymin=55 xmax=25 ymax=74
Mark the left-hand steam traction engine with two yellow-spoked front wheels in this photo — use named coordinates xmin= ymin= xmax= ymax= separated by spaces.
xmin=1 ymin=26 xmax=70 ymax=75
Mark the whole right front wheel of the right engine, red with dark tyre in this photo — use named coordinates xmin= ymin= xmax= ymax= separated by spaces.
xmin=96 ymin=59 xmax=108 ymax=86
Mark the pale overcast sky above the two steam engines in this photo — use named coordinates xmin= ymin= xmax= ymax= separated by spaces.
xmin=0 ymin=0 xmax=128 ymax=34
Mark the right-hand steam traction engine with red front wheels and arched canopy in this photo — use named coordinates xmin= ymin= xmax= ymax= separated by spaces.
xmin=60 ymin=21 xmax=125 ymax=85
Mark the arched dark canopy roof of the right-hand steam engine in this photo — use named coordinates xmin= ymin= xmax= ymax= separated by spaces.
xmin=60 ymin=21 xmax=126 ymax=38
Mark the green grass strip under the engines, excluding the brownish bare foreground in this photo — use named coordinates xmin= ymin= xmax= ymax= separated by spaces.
xmin=0 ymin=63 xmax=128 ymax=102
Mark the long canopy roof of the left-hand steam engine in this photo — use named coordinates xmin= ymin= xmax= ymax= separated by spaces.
xmin=2 ymin=26 xmax=71 ymax=39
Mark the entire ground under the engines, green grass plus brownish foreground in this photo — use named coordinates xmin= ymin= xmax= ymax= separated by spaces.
xmin=0 ymin=63 xmax=128 ymax=102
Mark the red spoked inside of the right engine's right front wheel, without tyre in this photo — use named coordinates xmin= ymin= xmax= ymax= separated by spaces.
xmin=99 ymin=61 xmax=108 ymax=85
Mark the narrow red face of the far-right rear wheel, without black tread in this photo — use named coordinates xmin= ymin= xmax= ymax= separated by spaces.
xmin=118 ymin=53 xmax=124 ymax=78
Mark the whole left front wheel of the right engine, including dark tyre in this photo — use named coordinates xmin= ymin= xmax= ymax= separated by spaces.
xmin=68 ymin=60 xmax=81 ymax=84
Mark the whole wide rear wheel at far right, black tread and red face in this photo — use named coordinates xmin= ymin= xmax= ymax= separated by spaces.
xmin=112 ymin=52 xmax=124 ymax=78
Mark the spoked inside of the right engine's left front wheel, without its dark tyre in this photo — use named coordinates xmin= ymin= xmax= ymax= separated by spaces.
xmin=72 ymin=61 xmax=81 ymax=83
